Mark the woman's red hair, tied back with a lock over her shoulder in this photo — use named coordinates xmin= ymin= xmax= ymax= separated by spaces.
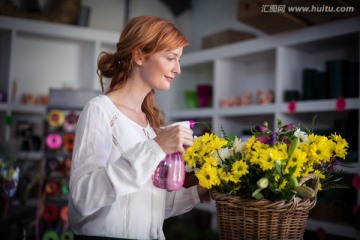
xmin=97 ymin=16 xmax=189 ymax=132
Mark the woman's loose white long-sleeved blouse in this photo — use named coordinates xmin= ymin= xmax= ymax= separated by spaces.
xmin=68 ymin=95 xmax=200 ymax=239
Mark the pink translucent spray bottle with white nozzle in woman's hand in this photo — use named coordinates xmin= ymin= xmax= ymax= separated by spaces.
xmin=152 ymin=120 xmax=195 ymax=191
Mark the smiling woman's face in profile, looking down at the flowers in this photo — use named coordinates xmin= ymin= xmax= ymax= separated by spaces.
xmin=140 ymin=47 xmax=183 ymax=90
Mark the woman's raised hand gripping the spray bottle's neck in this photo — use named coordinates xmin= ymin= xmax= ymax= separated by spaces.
xmin=154 ymin=125 xmax=193 ymax=154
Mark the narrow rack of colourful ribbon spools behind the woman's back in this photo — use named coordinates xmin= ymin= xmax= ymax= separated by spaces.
xmin=38 ymin=89 xmax=100 ymax=238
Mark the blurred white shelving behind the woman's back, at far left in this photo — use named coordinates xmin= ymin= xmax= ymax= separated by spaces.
xmin=0 ymin=16 xmax=119 ymax=145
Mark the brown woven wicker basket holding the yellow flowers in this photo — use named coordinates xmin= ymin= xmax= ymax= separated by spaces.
xmin=211 ymin=174 xmax=319 ymax=240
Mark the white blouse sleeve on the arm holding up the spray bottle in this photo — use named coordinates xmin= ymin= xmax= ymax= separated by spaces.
xmin=70 ymin=98 xmax=165 ymax=216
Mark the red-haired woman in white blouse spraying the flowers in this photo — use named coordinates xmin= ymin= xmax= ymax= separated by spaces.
xmin=69 ymin=16 xmax=208 ymax=240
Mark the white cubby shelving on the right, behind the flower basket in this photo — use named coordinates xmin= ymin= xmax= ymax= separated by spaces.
xmin=165 ymin=17 xmax=360 ymax=239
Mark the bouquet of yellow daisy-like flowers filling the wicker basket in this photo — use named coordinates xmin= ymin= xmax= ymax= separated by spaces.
xmin=184 ymin=120 xmax=348 ymax=201
